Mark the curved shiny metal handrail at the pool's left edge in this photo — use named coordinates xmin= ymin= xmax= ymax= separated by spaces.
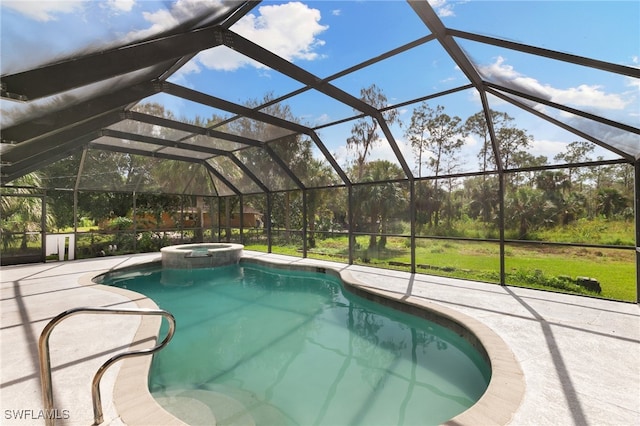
xmin=38 ymin=307 xmax=176 ymax=426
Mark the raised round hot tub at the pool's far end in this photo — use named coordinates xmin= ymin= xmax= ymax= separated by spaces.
xmin=160 ymin=243 xmax=244 ymax=269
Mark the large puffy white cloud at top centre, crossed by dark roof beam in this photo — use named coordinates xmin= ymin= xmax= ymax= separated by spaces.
xmin=174 ymin=2 xmax=328 ymax=74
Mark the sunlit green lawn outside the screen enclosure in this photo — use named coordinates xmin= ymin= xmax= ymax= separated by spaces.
xmin=246 ymin=237 xmax=636 ymax=301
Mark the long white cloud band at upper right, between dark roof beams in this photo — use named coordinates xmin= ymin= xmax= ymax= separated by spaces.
xmin=479 ymin=57 xmax=630 ymax=110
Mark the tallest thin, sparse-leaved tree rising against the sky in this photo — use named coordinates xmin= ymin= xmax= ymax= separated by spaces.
xmin=347 ymin=84 xmax=398 ymax=181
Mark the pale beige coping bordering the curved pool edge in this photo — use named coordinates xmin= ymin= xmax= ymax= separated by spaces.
xmin=85 ymin=257 xmax=525 ymax=426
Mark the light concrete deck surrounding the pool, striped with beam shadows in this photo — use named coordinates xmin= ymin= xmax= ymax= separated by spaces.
xmin=0 ymin=251 xmax=640 ymax=425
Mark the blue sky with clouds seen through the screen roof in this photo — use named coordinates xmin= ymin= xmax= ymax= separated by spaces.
xmin=0 ymin=0 xmax=640 ymax=175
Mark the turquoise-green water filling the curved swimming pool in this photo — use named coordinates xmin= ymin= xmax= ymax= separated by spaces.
xmin=104 ymin=263 xmax=491 ymax=426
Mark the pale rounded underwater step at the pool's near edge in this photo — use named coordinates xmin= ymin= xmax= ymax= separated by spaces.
xmin=153 ymin=389 xmax=256 ymax=426
